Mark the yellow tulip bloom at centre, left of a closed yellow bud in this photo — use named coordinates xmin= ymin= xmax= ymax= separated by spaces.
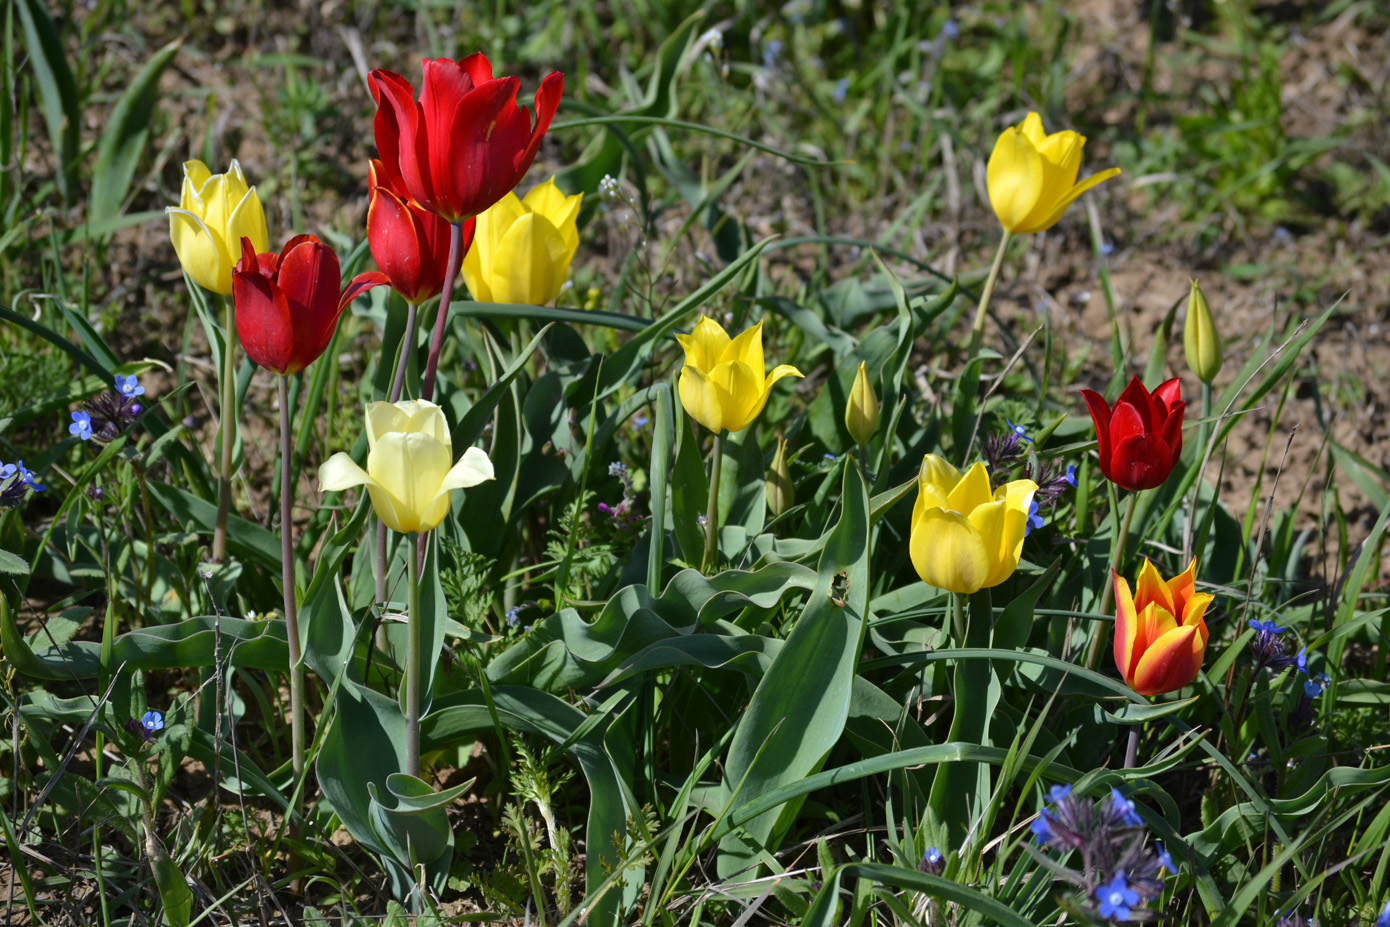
xmin=676 ymin=315 xmax=802 ymax=434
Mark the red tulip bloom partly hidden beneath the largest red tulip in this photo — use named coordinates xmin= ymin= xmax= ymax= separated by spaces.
xmin=367 ymin=161 xmax=474 ymax=306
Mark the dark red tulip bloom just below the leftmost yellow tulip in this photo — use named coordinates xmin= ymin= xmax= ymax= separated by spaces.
xmin=232 ymin=235 xmax=391 ymax=377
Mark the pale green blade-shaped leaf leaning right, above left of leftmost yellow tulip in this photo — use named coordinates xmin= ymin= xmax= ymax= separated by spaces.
xmin=88 ymin=38 xmax=183 ymax=222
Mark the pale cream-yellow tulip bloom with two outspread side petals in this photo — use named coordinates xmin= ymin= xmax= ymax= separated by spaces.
xmin=318 ymin=399 xmax=492 ymax=534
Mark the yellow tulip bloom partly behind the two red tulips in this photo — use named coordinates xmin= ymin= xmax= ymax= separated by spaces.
xmin=463 ymin=177 xmax=584 ymax=306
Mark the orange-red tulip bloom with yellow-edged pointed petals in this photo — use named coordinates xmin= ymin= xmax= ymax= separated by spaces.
xmin=1115 ymin=559 xmax=1212 ymax=695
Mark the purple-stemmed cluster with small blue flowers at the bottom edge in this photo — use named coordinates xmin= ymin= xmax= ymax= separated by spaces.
xmin=1029 ymin=785 xmax=1177 ymax=921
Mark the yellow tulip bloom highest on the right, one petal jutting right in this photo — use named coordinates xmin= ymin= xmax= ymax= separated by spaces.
xmin=986 ymin=113 xmax=1120 ymax=235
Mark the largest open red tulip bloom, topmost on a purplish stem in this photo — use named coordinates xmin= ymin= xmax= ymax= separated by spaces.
xmin=370 ymin=51 xmax=564 ymax=222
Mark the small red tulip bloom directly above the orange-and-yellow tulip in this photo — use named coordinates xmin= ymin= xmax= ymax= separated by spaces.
xmin=1081 ymin=377 xmax=1187 ymax=489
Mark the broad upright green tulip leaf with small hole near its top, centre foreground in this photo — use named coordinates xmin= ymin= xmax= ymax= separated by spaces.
xmin=717 ymin=467 xmax=869 ymax=880
